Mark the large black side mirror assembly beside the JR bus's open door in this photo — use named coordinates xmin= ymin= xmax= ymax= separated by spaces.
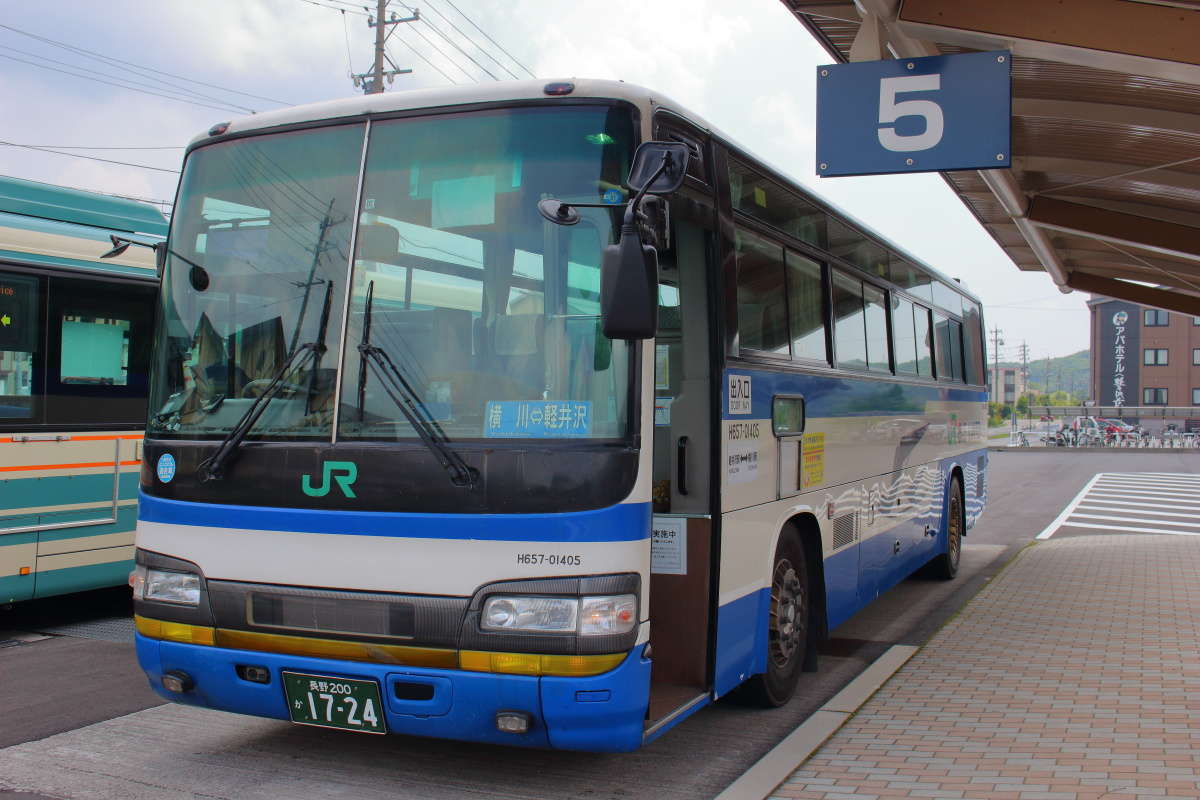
xmin=600 ymin=142 xmax=688 ymax=339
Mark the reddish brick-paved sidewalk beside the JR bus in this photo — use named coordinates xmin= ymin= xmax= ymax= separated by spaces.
xmin=770 ymin=534 xmax=1200 ymax=800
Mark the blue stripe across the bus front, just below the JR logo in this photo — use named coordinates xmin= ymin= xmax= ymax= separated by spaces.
xmin=138 ymin=493 xmax=650 ymax=542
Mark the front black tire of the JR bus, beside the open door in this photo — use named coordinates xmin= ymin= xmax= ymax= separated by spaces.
xmin=739 ymin=530 xmax=812 ymax=708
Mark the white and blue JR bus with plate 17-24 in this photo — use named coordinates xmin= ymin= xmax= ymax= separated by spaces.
xmin=131 ymin=80 xmax=986 ymax=751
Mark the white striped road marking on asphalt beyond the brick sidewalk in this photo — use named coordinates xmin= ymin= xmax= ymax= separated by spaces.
xmin=1037 ymin=473 xmax=1200 ymax=539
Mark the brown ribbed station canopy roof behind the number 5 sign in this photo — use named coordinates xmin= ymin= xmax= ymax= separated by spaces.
xmin=781 ymin=0 xmax=1200 ymax=315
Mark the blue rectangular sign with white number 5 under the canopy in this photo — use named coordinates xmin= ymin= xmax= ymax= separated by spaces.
xmin=817 ymin=50 xmax=1013 ymax=176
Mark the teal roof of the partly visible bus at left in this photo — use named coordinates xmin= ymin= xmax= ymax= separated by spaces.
xmin=0 ymin=176 xmax=167 ymax=236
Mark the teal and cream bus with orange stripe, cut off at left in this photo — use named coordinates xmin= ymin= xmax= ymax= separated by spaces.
xmin=0 ymin=176 xmax=167 ymax=606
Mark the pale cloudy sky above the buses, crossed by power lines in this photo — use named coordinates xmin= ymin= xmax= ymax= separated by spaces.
xmin=0 ymin=0 xmax=1088 ymax=360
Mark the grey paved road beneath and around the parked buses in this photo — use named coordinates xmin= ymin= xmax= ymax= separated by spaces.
xmin=0 ymin=452 xmax=1180 ymax=800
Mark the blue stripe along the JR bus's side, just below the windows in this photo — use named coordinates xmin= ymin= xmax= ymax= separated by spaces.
xmin=721 ymin=368 xmax=988 ymax=420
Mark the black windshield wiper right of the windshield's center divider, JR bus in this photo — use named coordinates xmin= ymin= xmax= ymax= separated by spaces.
xmin=359 ymin=281 xmax=479 ymax=488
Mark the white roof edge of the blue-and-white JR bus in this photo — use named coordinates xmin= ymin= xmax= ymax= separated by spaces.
xmin=188 ymin=78 xmax=979 ymax=302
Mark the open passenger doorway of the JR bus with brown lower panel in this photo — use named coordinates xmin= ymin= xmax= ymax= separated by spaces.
xmin=647 ymin=199 xmax=714 ymax=735
